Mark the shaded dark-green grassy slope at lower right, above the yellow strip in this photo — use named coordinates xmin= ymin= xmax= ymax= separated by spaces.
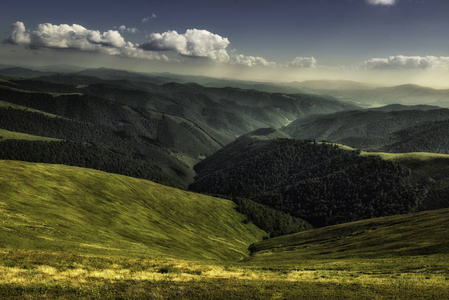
xmin=248 ymin=209 xmax=449 ymax=264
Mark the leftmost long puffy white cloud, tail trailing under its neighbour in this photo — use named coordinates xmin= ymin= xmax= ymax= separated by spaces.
xmin=6 ymin=22 xmax=167 ymax=60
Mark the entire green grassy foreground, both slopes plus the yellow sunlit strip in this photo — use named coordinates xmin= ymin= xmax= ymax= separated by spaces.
xmin=0 ymin=161 xmax=449 ymax=299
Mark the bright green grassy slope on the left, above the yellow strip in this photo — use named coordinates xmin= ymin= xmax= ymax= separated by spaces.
xmin=0 ymin=161 xmax=265 ymax=260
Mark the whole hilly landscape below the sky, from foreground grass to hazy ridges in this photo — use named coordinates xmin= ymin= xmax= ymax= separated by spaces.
xmin=0 ymin=67 xmax=449 ymax=299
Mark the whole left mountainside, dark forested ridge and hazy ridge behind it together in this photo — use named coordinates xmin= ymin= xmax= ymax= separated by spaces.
xmin=0 ymin=69 xmax=354 ymax=188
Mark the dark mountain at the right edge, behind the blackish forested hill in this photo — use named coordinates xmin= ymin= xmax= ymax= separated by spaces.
xmin=282 ymin=105 xmax=449 ymax=153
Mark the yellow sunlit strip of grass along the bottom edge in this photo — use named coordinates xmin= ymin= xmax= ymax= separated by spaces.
xmin=0 ymin=251 xmax=449 ymax=299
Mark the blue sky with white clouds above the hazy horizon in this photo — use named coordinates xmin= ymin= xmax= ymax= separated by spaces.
xmin=0 ymin=0 xmax=449 ymax=88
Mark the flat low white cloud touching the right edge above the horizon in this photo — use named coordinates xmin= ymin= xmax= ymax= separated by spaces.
xmin=364 ymin=55 xmax=449 ymax=70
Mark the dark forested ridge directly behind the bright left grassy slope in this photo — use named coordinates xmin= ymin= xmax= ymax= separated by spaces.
xmin=0 ymin=84 xmax=217 ymax=188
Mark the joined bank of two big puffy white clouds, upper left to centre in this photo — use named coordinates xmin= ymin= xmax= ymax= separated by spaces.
xmin=6 ymin=22 xmax=276 ymax=67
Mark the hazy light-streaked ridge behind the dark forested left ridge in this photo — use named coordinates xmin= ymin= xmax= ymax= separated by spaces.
xmin=7 ymin=69 xmax=357 ymax=144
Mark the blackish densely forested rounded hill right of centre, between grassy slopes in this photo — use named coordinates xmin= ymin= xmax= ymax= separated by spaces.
xmin=189 ymin=136 xmax=426 ymax=227
